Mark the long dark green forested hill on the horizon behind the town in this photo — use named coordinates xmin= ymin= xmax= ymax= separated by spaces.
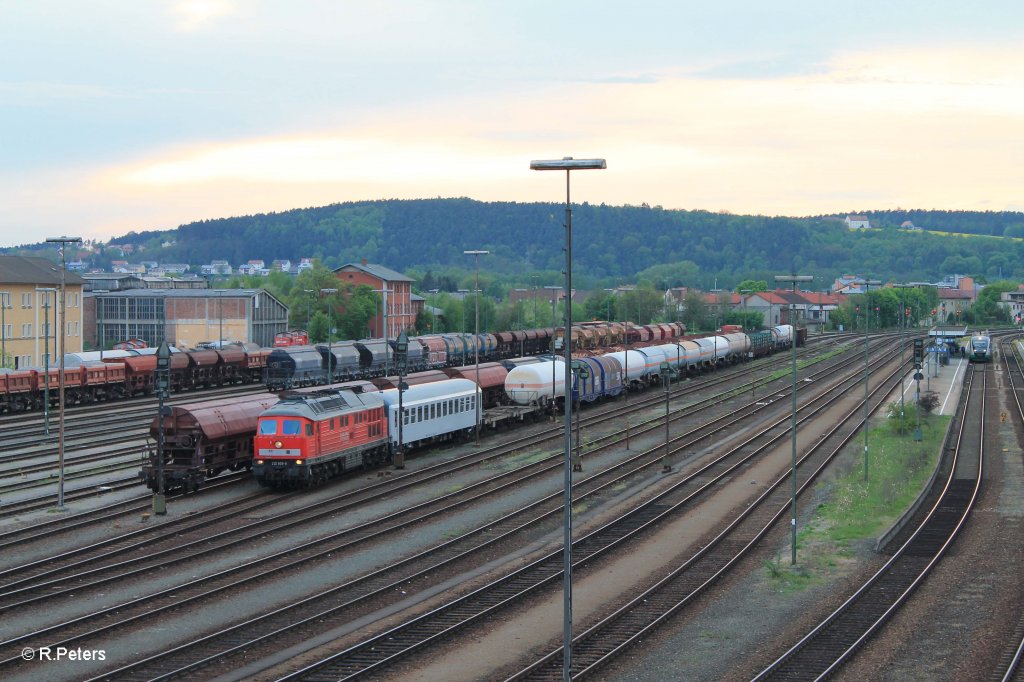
xmin=101 ymin=199 xmax=1024 ymax=288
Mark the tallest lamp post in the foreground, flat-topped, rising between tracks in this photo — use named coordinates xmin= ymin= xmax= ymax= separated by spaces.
xmin=529 ymin=157 xmax=607 ymax=682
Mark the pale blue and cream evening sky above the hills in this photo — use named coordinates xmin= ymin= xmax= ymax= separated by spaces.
xmin=0 ymin=0 xmax=1024 ymax=247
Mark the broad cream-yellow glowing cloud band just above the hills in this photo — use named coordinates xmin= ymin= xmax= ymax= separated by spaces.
xmin=8 ymin=42 xmax=1024 ymax=245
